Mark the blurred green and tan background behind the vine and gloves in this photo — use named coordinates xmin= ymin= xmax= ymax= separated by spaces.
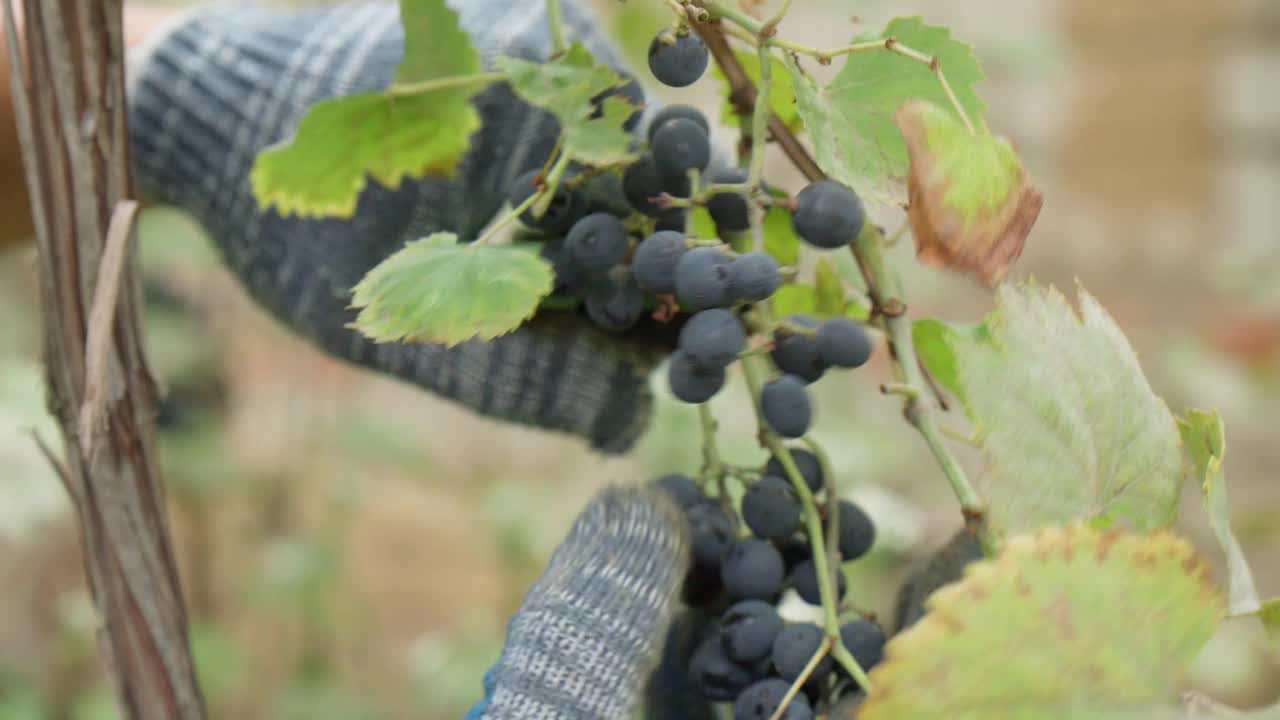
xmin=0 ymin=0 xmax=1280 ymax=720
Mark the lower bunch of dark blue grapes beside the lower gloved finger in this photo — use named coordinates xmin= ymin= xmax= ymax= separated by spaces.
xmin=655 ymin=448 xmax=886 ymax=707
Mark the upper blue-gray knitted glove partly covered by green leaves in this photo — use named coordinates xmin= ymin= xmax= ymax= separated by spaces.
xmin=129 ymin=0 xmax=673 ymax=452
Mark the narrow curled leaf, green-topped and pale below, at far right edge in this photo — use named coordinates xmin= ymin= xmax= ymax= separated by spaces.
xmin=1178 ymin=409 xmax=1262 ymax=615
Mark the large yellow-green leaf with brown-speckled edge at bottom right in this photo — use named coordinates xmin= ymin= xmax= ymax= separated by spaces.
xmin=858 ymin=524 xmax=1224 ymax=720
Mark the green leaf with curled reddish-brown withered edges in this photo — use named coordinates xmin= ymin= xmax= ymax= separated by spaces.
xmin=896 ymin=100 xmax=1044 ymax=286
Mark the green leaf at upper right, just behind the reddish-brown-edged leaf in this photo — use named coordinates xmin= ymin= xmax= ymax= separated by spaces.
xmin=785 ymin=18 xmax=986 ymax=205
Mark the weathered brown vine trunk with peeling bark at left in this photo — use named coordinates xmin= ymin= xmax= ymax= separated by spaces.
xmin=4 ymin=0 xmax=205 ymax=720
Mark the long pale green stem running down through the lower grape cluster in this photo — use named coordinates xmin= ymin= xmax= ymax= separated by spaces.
xmin=742 ymin=357 xmax=870 ymax=692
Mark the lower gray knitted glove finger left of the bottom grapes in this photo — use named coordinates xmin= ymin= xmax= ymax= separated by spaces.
xmin=466 ymin=488 xmax=690 ymax=720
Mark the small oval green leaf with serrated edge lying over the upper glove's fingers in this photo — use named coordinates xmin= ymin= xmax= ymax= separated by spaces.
xmin=352 ymin=232 xmax=553 ymax=346
